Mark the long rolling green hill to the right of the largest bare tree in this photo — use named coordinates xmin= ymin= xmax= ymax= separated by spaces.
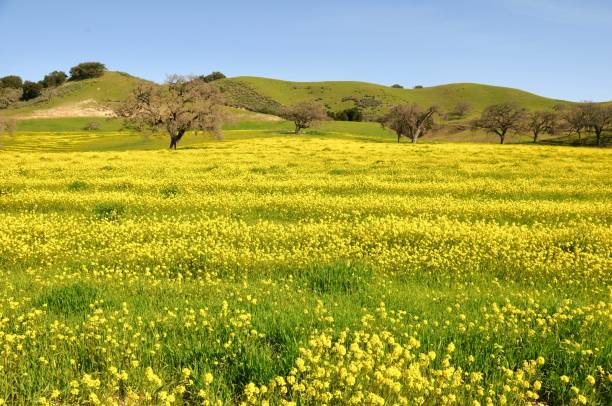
xmin=218 ymin=77 xmax=568 ymax=116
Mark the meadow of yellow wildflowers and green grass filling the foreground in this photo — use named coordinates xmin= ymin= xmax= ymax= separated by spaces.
xmin=0 ymin=135 xmax=612 ymax=405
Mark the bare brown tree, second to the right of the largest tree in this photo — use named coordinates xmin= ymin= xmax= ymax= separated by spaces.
xmin=381 ymin=104 xmax=438 ymax=144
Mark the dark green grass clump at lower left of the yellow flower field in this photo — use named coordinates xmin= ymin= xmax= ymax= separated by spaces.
xmin=36 ymin=282 xmax=99 ymax=316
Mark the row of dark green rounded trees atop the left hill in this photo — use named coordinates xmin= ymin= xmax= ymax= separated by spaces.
xmin=0 ymin=62 xmax=106 ymax=105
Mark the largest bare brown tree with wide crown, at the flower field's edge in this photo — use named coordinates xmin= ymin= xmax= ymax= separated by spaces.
xmin=115 ymin=75 xmax=223 ymax=149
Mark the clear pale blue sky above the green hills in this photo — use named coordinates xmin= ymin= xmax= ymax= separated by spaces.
xmin=0 ymin=0 xmax=612 ymax=101
